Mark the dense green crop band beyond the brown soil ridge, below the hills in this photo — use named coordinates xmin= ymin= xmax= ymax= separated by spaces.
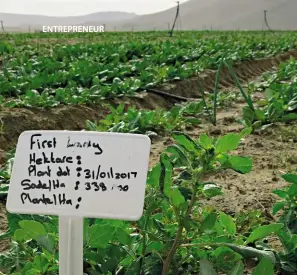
xmin=0 ymin=32 xmax=297 ymax=107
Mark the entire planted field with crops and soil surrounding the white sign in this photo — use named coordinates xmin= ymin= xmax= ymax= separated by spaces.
xmin=0 ymin=31 xmax=297 ymax=275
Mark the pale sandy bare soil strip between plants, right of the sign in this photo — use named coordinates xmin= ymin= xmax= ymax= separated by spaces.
xmin=150 ymin=103 xmax=297 ymax=213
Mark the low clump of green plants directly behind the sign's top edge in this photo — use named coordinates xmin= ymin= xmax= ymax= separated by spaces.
xmin=86 ymin=102 xmax=203 ymax=136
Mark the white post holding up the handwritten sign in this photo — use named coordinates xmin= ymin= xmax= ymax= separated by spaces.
xmin=59 ymin=216 xmax=83 ymax=275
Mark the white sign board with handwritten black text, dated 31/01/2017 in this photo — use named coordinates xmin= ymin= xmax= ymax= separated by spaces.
xmin=7 ymin=131 xmax=151 ymax=221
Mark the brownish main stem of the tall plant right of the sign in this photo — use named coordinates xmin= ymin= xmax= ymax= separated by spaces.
xmin=162 ymin=185 xmax=197 ymax=275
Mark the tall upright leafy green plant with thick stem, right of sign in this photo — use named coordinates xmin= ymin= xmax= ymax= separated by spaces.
xmin=160 ymin=130 xmax=258 ymax=274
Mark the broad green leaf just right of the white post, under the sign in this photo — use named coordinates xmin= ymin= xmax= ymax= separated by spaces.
xmin=88 ymin=224 xmax=115 ymax=248
